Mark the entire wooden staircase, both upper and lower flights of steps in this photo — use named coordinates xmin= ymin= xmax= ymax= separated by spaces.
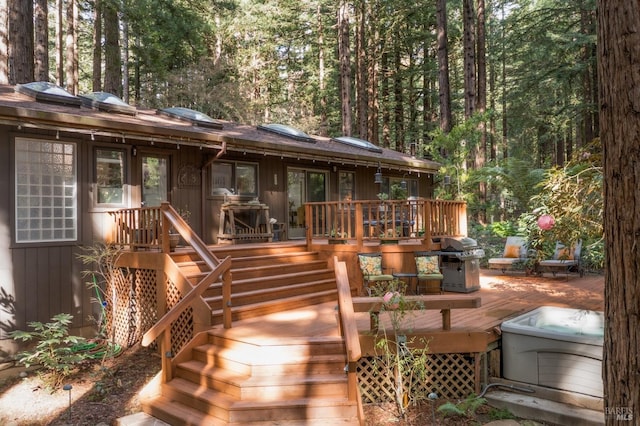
xmin=143 ymin=244 xmax=360 ymax=426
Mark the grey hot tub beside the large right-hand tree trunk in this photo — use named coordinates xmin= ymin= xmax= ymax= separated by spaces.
xmin=501 ymin=306 xmax=604 ymax=397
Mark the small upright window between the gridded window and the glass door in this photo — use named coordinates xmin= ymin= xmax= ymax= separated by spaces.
xmin=95 ymin=148 xmax=126 ymax=205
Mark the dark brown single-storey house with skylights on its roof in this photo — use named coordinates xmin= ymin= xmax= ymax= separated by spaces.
xmin=0 ymin=84 xmax=438 ymax=360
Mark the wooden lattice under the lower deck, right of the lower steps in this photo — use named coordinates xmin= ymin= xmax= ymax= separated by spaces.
xmin=358 ymin=354 xmax=475 ymax=404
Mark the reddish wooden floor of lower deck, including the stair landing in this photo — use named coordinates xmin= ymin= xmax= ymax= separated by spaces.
xmin=218 ymin=270 xmax=604 ymax=353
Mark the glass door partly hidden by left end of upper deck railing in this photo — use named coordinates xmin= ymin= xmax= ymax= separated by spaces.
xmin=287 ymin=169 xmax=328 ymax=238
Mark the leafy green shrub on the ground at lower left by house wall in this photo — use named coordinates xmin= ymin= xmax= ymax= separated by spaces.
xmin=9 ymin=313 xmax=86 ymax=389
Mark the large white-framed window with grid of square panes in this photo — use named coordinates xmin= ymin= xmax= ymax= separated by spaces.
xmin=15 ymin=138 xmax=78 ymax=243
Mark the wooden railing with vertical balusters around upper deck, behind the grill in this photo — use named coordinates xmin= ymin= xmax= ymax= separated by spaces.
xmin=305 ymin=199 xmax=467 ymax=244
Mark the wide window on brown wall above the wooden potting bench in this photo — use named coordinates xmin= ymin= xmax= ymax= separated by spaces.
xmin=211 ymin=163 xmax=258 ymax=197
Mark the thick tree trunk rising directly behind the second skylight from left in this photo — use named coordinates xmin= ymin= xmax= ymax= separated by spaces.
xmin=103 ymin=2 xmax=122 ymax=96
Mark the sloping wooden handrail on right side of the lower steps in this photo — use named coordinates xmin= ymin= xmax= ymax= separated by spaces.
xmin=333 ymin=256 xmax=364 ymax=425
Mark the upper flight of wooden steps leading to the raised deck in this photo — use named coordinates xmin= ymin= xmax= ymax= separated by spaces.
xmin=172 ymin=242 xmax=337 ymax=324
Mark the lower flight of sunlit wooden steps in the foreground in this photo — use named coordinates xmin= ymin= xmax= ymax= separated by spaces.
xmin=144 ymin=329 xmax=359 ymax=426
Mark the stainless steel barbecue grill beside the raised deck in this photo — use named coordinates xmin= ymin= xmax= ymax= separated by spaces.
xmin=436 ymin=237 xmax=484 ymax=293
